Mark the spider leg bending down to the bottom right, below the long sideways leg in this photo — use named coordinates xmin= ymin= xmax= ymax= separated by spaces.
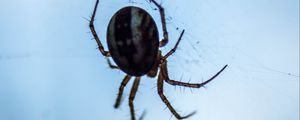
xmin=157 ymin=72 xmax=196 ymax=119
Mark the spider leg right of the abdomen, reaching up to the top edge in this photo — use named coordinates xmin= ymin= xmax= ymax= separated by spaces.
xmin=150 ymin=0 xmax=169 ymax=47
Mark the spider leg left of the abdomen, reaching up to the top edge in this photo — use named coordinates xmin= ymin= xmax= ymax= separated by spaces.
xmin=89 ymin=0 xmax=110 ymax=57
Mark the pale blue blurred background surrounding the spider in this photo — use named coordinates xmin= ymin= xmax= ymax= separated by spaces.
xmin=0 ymin=0 xmax=299 ymax=120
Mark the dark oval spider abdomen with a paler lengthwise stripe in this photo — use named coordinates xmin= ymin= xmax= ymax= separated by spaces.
xmin=107 ymin=6 xmax=159 ymax=76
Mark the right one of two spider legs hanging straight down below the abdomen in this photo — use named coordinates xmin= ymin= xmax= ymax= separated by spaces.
xmin=129 ymin=77 xmax=141 ymax=120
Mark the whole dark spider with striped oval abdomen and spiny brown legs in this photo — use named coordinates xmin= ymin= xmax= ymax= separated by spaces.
xmin=89 ymin=0 xmax=227 ymax=120
